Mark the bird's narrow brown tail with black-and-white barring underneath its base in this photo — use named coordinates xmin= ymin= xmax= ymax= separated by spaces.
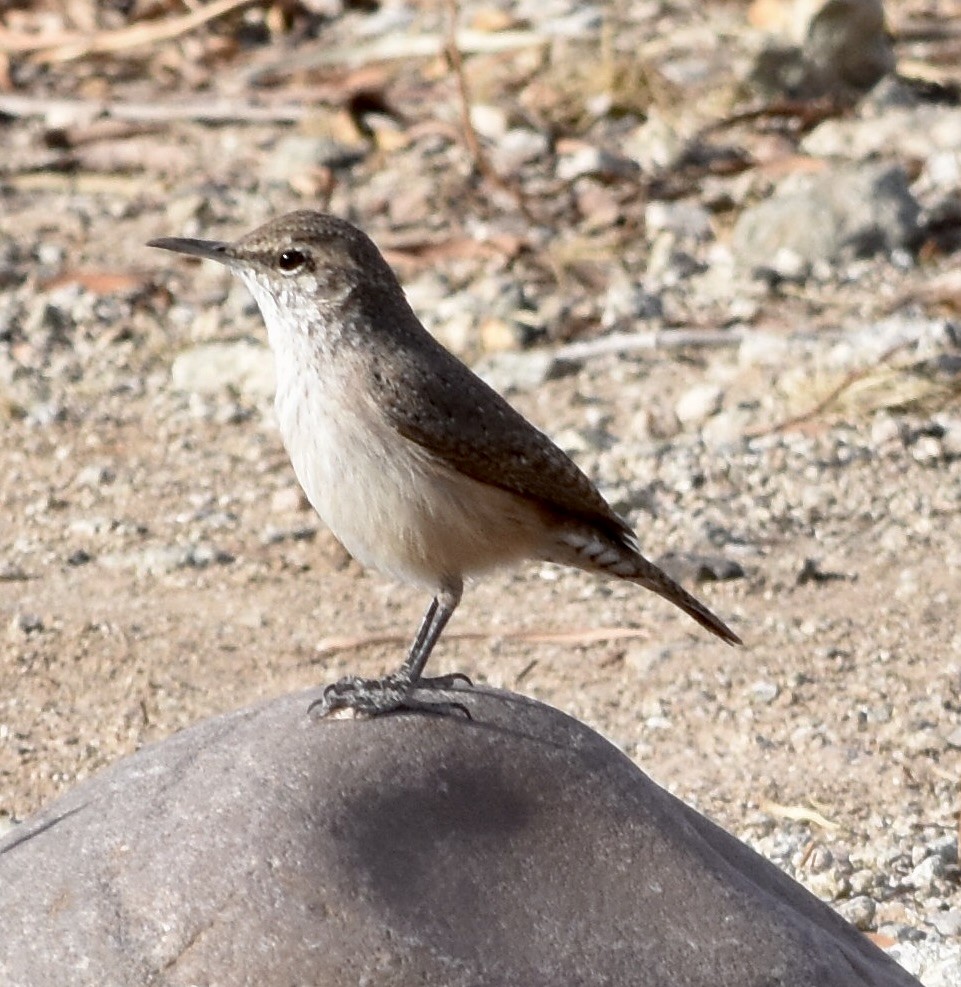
xmin=548 ymin=531 xmax=744 ymax=644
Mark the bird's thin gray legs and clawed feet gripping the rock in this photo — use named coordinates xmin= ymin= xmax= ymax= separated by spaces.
xmin=310 ymin=580 xmax=471 ymax=718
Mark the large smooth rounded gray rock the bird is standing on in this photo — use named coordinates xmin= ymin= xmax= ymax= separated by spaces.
xmin=0 ymin=690 xmax=918 ymax=987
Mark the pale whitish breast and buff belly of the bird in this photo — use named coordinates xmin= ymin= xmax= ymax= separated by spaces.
xmin=248 ymin=268 xmax=549 ymax=591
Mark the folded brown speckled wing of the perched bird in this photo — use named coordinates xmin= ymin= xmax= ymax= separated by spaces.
xmin=364 ymin=304 xmax=633 ymax=542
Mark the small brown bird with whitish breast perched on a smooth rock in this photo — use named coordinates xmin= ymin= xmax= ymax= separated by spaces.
xmin=149 ymin=210 xmax=741 ymax=715
